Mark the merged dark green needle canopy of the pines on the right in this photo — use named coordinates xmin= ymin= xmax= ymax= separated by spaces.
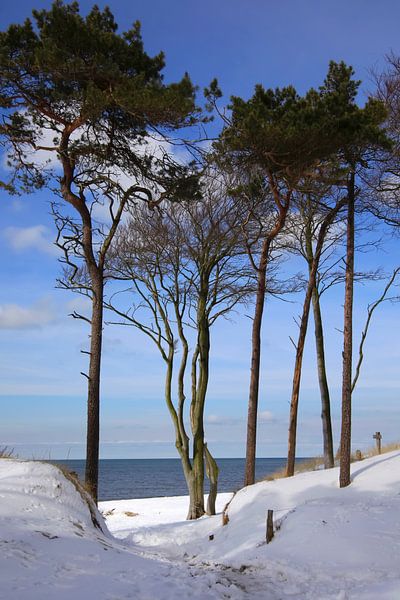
xmin=217 ymin=62 xmax=387 ymax=179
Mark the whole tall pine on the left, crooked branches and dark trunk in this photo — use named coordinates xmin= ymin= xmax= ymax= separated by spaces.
xmin=0 ymin=0 xmax=196 ymax=499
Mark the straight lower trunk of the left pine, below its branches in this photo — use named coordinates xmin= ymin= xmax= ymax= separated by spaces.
xmin=85 ymin=270 xmax=104 ymax=503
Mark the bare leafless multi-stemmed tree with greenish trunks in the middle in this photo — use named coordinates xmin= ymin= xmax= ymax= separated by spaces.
xmin=106 ymin=185 xmax=251 ymax=519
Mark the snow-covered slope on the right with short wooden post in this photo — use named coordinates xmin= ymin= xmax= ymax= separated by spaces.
xmin=104 ymin=452 xmax=400 ymax=600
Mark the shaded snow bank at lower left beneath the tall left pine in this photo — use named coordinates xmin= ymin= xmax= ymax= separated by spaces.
xmin=0 ymin=459 xmax=247 ymax=600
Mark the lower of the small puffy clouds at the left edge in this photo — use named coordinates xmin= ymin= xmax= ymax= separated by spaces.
xmin=0 ymin=300 xmax=55 ymax=329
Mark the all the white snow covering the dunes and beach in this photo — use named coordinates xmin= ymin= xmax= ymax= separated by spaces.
xmin=0 ymin=451 xmax=400 ymax=600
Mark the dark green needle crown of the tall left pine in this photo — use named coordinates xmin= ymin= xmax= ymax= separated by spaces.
xmin=0 ymin=0 xmax=198 ymax=188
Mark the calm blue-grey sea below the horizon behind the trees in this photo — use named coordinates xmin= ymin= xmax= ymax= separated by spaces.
xmin=53 ymin=458 xmax=301 ymax=500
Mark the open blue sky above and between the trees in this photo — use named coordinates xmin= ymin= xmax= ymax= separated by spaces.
xmin=0 ymin=0 xmax=400 ymax=458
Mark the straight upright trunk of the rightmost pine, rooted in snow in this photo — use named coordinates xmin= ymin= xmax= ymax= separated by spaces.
xmin=339 ymin=170 xmax=355 ymax=488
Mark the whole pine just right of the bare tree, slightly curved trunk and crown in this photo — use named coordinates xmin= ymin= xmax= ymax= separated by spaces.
xmin=208 ymin=62 xmax=376 ymax=485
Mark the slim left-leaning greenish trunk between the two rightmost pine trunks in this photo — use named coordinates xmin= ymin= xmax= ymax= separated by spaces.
xmin=312 ymin=287 xmax=335 ymax=469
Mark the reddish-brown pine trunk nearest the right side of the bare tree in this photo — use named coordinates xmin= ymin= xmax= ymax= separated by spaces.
xmin=244 ymin=240 xmax=270 ymax=485
